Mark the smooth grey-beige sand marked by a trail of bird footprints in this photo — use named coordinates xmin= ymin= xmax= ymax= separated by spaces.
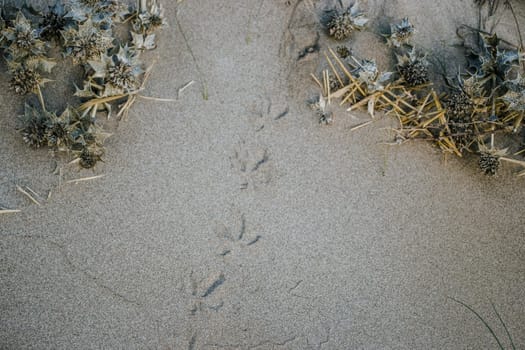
xmin=0 ymin=0 xmax=525 ymax=350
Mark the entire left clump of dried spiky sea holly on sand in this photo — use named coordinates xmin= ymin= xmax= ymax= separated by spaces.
xmin=0 ymin=0 xmax=166 ymax=168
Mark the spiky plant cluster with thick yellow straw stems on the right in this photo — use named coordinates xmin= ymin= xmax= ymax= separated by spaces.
xmin=315 ymin=1 xmax=525 ymax=175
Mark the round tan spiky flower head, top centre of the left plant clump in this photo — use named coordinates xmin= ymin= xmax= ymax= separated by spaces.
xmin=62 ymin=19 xmax=113 ymax=63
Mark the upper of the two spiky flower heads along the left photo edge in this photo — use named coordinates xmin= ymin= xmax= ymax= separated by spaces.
xmin=2 ymin=12 xmax=45 ymax=60
